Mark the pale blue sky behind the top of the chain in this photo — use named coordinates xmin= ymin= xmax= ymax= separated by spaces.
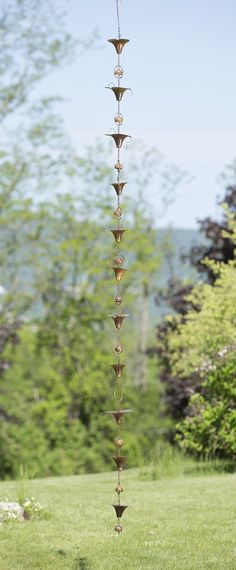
xmin=40 ymin=0 xmax=236 ymax=228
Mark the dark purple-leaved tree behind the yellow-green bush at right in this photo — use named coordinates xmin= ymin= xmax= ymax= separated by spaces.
xmin=156 ymin=178 xmax=236 ymax=421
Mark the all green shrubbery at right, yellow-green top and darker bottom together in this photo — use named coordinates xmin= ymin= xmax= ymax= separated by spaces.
xmin=166 ymin=217 xmax=236 ymax=461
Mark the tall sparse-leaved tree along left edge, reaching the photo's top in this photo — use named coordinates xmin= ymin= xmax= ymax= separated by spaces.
xmin=0 ymin=0 xmax=103 ymax=475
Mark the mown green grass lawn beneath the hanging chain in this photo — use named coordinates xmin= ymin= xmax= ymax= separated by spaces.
xmin=0 ymin=470 xmax=236 ymax=570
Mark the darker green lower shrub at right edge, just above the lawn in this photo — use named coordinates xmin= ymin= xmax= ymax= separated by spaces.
xmin=176 ymin=354 xmax=236 ymax=461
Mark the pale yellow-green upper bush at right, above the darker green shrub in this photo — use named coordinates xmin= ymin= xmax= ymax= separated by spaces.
xmin=168 ymin=262 xmax=236 ymax=374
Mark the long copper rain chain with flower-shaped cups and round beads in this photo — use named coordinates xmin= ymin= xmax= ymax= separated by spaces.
xmin=105 ymin=0 xmax=132 ymax=534
